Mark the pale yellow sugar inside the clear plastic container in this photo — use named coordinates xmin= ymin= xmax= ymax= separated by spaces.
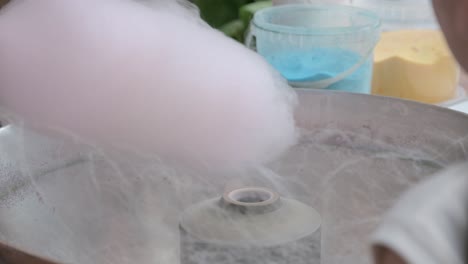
xmin=372 ymin=30 xmax=459 ymax=103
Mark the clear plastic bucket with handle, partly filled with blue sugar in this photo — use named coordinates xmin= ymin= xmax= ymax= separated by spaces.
xmin=246 ymin=4 xmax=380 ymax=93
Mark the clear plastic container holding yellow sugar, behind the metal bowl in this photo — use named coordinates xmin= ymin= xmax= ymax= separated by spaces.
xmin=352 ymin=0 xmax=465 ymax=105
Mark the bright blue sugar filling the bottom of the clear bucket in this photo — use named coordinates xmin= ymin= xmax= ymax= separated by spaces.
xmin=265 ymin=48 xmax=372 ymax=93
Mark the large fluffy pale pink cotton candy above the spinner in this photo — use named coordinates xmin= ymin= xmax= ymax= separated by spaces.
xmin=0 ymin=0 xmax=296 ymax=165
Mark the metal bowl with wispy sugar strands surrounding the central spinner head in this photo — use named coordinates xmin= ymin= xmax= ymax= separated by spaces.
xmin=0 ymin=90 xmax=468 ymax=264
